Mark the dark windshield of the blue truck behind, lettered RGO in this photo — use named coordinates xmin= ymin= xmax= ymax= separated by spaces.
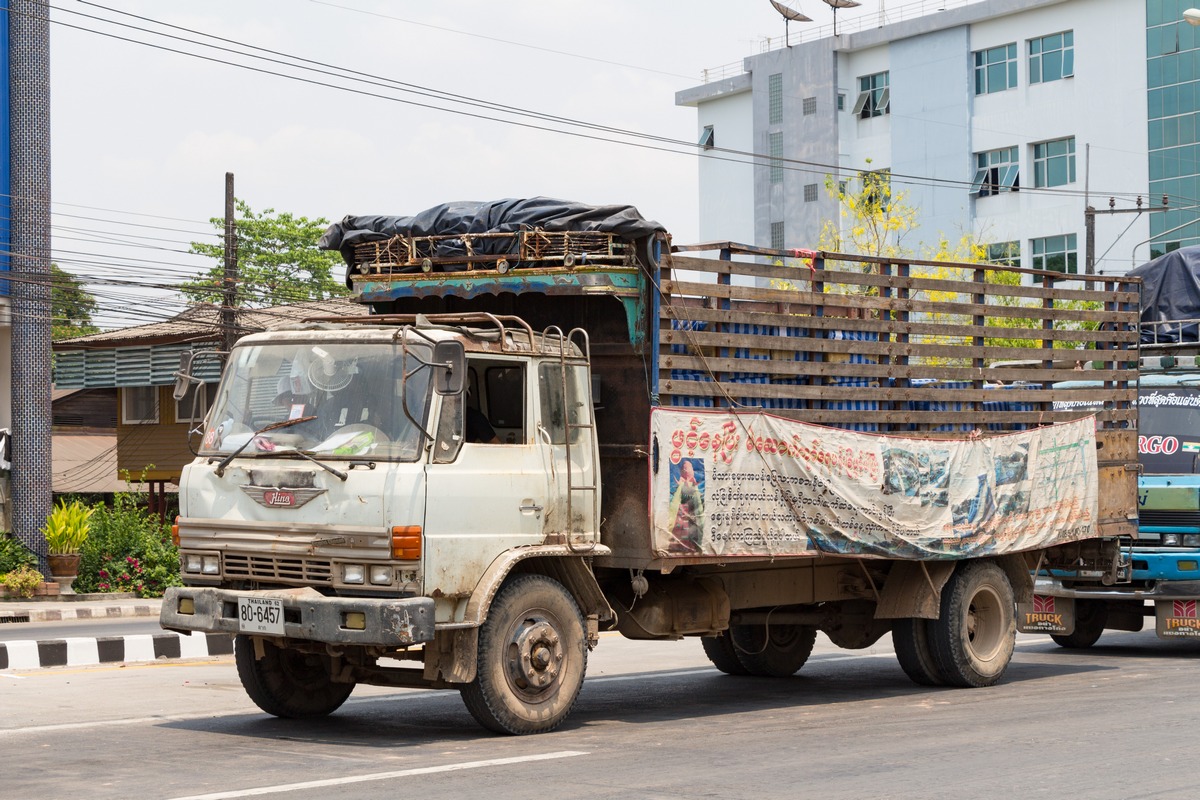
xmin=1138 ymin=386 xmax=1200 ymax=475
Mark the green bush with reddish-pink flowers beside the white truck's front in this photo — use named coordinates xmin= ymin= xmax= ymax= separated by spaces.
xmin=74 ymin=492 xmax=180 ymax=597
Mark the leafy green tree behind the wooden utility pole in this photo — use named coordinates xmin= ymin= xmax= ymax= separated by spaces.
xmin=180 ymin=200 xmax=347 ymax=307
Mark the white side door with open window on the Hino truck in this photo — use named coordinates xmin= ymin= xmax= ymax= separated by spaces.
xmin=424 ymin=360 xmax=548 ymax=595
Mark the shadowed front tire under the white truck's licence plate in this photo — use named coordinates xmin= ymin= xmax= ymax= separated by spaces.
xmin=233 ymin=636 xmax=354 ymax=720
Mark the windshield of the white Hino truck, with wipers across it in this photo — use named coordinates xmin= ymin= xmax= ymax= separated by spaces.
xmin=199 ymin=342 xmax=430 ymax=461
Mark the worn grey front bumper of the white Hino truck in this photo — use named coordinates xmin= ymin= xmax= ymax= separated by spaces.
xmin=158 ymin=587 xmax=433 ymax=648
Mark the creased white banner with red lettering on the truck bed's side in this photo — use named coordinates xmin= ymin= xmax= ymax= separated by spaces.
xmin=650 ymin=409 xmax=1098 ymax=559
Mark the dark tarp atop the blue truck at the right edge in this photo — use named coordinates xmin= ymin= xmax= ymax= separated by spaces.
xmin=1129 ymin=246 xmax=1200 ymax=344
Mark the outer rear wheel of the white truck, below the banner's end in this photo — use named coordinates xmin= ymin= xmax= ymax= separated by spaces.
xmin=929 ymin=561 xmax=1016 ymax=687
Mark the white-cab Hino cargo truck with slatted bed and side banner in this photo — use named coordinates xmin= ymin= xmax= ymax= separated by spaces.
xmin=161 ymin=209 xmax=1136 ymax=734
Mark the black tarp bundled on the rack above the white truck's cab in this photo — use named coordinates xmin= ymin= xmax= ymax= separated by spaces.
xmin=318 ymin=197 xmax=666 ymax=271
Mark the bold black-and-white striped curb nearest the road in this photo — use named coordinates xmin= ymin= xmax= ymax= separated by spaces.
xmin=0 ymin=632 xmax=233 ymax=669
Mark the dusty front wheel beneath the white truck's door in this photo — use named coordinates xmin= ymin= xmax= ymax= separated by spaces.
xmin=460 ymin=575 xmax=588 ymax=735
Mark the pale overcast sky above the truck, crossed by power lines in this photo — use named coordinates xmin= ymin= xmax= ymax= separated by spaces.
xmin=50 ymin=0 xmax=940 ymax=327
